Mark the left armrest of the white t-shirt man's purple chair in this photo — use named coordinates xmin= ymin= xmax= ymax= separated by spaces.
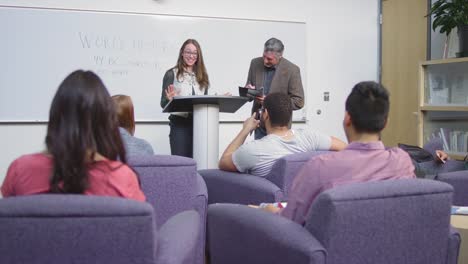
xmin=198 ymin=169 xmax=283 ymax=204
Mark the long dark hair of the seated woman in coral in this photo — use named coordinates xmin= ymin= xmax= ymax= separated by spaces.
xmin=45 ymin=70 xmax=126 ymax=194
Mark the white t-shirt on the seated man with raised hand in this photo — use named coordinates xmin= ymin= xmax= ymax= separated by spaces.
xmin=232 ymin=130 xmax=331 ymax=177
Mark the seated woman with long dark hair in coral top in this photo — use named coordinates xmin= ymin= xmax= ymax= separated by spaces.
xmin=1 ymin=70 xmax=145 ymax=201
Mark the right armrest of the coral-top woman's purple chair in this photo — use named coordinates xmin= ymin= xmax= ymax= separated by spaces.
xmin=156 ymin=210 xmax=200 ymax=264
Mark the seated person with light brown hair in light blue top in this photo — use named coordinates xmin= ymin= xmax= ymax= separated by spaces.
xmin=112 ymin=94 xmax=154 ymax=158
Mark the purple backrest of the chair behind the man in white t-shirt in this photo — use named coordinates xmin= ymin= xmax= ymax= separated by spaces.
xmin=266 ymin=151 xmax=330 ymax=198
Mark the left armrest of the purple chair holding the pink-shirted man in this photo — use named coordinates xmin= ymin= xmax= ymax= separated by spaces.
xmin=207 ymin=204 xmax=326 ymax=264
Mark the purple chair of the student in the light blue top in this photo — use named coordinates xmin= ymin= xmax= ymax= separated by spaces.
xmin=128 ymin=155 xmax=208 ymax=264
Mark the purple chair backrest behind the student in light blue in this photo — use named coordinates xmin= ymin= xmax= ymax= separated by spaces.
xmin=128 ymin=155 xmax=198 ymax=227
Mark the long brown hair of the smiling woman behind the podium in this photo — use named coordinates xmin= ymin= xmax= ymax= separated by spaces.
xmin=175 ymin=39 xmax=210 ymax=89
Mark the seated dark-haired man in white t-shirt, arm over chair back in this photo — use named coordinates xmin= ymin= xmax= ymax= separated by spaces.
xmin=219 ymin=93 xmax=346 ymax=177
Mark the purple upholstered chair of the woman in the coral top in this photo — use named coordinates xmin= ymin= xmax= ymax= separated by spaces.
xmin=0 ymin=194 xmax=200 ymax=264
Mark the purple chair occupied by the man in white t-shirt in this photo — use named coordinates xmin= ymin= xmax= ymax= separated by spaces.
xmin=198 ymin=151 xmax=329 ymax=204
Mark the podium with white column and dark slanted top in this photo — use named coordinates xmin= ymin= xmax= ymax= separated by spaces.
xmin=163 ymin=95 xmax=249 ymax=169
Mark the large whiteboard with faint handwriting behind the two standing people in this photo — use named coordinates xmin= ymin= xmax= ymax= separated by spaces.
xmin=0 ymin=6 xmax=307 ymax=122
